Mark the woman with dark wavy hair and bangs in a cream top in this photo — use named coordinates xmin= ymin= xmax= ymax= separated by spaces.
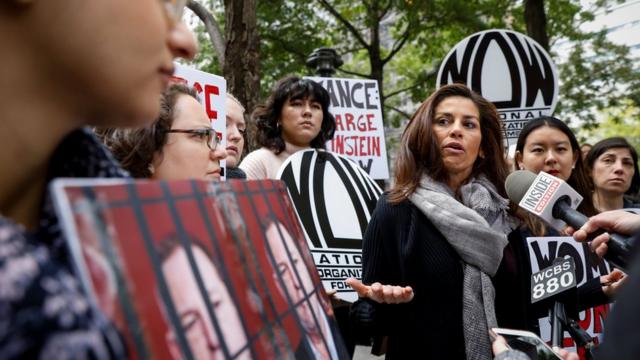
xmin=239 ymin=76 xmax=336 ymax=180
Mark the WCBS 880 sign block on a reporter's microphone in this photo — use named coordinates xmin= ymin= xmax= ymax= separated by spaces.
xmin=531 ymin=258 xmax=576 ymax=303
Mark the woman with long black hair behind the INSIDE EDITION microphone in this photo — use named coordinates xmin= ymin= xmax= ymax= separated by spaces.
xmin=495 ymin=116 xmax=624 ymax=333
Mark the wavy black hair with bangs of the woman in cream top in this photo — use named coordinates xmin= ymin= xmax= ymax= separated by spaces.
xmin=252 ymin=76 xmax=336 ymax=154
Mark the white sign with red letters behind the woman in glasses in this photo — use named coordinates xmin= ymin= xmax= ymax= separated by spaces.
xmin=172 ymin=63 xmax=227 ymax=180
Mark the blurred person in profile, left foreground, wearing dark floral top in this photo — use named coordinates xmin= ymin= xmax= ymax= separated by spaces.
xmin=0 ymin=0 xmax=196 ymax=359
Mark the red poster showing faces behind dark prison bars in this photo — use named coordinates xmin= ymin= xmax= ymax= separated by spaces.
xmin=53 ymin=179 xmax=346 ymax=359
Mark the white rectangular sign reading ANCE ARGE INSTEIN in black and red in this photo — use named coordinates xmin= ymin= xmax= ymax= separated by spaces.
xmin=307 ymin=77 xmax=389 ymax=179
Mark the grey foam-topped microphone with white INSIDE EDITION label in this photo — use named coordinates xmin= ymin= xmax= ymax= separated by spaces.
xmin=505 ymin=170 xmax=631 ymax=269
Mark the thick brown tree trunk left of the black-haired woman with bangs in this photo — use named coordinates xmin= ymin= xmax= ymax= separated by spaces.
xmin=223 ymin=0 xmax=260 ymax=150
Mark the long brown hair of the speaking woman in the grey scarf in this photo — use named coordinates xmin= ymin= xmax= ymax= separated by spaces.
xmin=388 ymin=84 xmax=508 ymax=203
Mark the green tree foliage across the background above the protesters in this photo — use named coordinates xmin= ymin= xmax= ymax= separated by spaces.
xmin=190 ymin=0 xmax=640 ymax=136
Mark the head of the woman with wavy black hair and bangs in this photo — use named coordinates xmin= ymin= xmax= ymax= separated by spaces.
xmin=253 ymin=76 xmax=336 ymax=154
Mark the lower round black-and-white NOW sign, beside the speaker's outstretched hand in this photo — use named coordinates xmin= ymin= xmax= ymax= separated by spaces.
xmin=278 ymin=150 xmax=382 ymax=302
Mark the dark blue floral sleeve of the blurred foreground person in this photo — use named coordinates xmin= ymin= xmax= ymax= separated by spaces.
xmin=0 ymin=218 xmax=124 ymax=359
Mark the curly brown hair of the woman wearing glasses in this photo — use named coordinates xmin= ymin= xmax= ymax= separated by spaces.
xmin=94 ymin=83 xmax=198 ymax=178
